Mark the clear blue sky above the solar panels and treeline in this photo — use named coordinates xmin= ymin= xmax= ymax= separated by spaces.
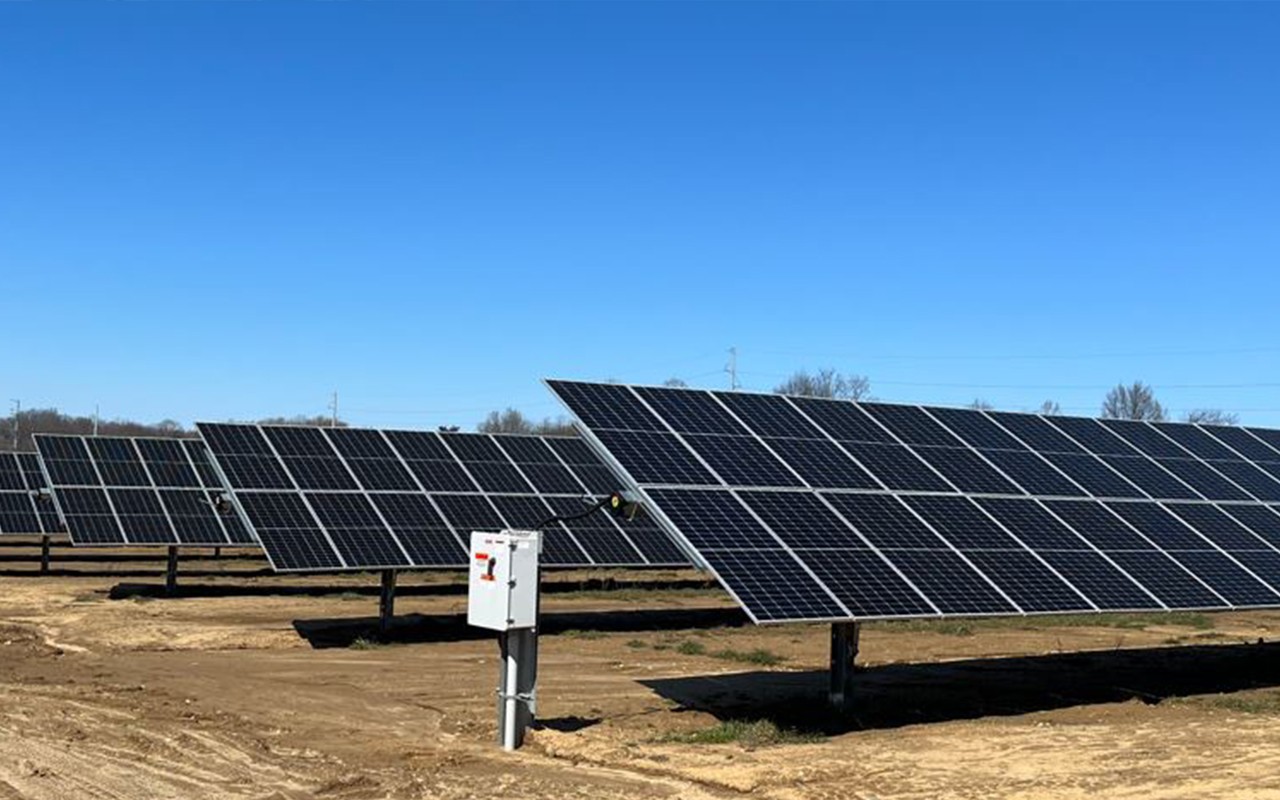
xmin=0 ymin=1 xmax=1280 ymax=426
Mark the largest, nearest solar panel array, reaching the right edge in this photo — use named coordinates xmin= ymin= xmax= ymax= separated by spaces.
xmin=549 ymin=380 xmax=1280 ymax=622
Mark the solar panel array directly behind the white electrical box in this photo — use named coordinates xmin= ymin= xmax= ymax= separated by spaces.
xmin=197 ymin=422 xmax=689 ymax=571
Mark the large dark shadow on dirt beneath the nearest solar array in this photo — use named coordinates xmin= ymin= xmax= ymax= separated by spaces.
xmin=640 ymin=643 xmax=1280 ymax=733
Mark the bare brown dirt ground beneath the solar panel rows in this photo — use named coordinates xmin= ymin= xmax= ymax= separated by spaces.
xmin=0 ymin=541 xmax=1280 ymax=800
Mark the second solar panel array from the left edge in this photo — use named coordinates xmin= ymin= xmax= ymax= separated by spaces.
xmin=35 ymin=434 xmax=256 ymax=547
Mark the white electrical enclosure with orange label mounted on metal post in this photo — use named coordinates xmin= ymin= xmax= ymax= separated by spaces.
xmin=467 ymin=531 xmax=540 ymax=631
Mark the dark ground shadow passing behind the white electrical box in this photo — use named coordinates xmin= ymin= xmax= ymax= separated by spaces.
xmin=293 ymin=608 xmax=748 ymax=649
